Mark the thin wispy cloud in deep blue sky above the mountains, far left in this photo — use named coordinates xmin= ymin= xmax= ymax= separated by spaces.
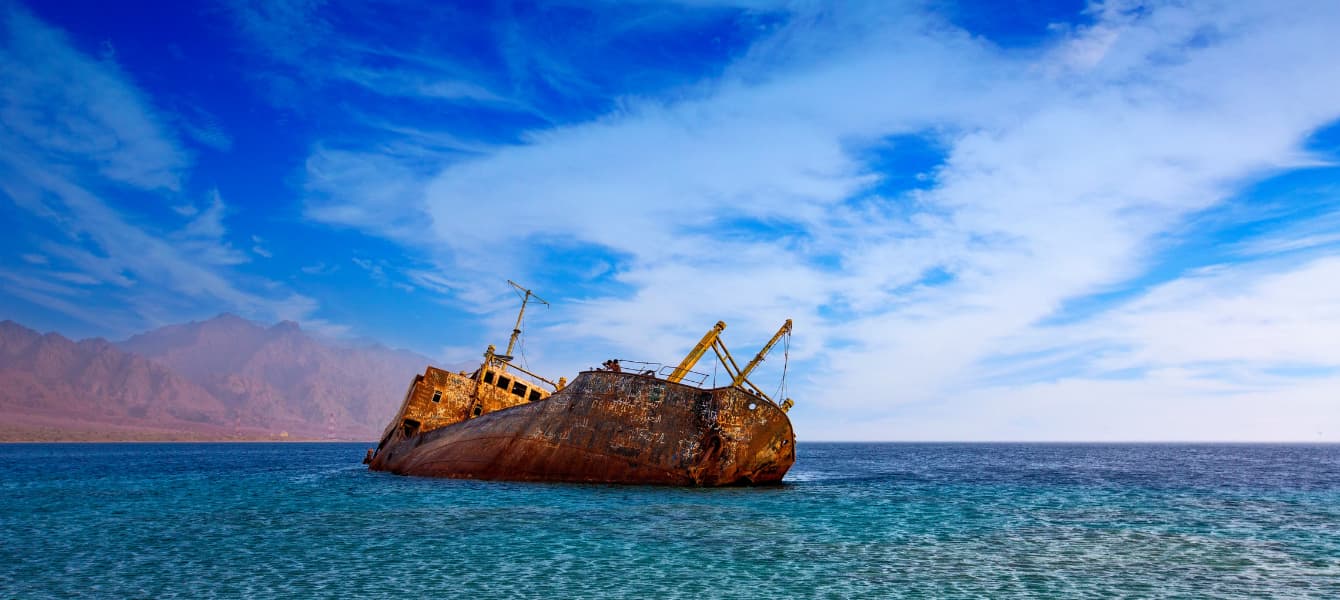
xmin=0 ymin=0 xmax=324 ymax=335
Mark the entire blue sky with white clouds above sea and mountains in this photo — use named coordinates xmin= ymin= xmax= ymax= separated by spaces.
xmin=0 ymin=0 xmax=1340 ymax=442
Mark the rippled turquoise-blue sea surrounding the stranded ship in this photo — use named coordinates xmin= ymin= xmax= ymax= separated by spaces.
xmin=0 ymin=443 xmax=1340 ymax=599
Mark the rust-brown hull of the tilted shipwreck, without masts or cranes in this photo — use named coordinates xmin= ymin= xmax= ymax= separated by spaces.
xmin=370 ymin=368 xmax=796 ymax=486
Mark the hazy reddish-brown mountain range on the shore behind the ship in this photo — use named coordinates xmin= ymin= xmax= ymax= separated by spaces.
xmin=0 ymin=313 xmax=450 ymax=441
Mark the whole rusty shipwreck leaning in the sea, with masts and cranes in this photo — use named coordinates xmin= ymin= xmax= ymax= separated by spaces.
xmin=364 ymin=281 xmax=796 ymax=486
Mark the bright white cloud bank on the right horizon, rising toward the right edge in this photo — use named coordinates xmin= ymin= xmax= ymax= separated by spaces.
xmin=879 ymin=250 xmax=1340 ymax=441
